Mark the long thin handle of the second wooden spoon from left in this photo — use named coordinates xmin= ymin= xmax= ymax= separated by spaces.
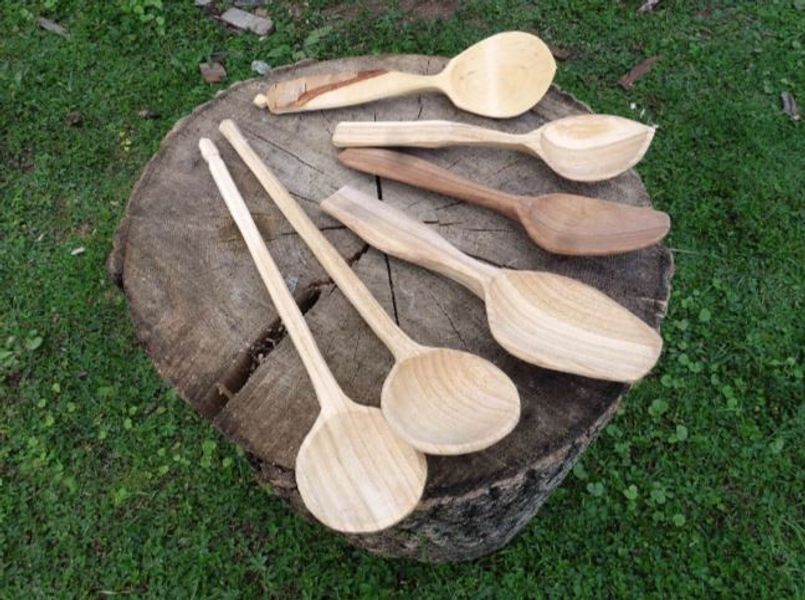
xmin=218 ymin=119 xmax=418 ymax=360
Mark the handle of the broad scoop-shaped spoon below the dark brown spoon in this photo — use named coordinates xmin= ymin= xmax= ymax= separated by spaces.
xmin=321 ymin=186 xmax=497 ymax=298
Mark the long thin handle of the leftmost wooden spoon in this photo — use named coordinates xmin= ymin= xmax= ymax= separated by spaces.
xmin=198 ymin=138 xmax=348 ymax=412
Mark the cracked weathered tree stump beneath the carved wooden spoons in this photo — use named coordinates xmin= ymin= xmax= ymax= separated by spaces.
xmin=109 ymin=56 xmax=673 ymax=561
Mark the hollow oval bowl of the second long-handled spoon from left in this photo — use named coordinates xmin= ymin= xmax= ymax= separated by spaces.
xmin=381 ymin=348 xmax=520 ymax=455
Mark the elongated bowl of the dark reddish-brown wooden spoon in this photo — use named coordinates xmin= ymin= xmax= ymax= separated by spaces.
xmin=517 ymin=194 xmax=671 ymax=256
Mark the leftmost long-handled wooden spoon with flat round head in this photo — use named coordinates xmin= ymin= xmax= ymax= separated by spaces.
xmin=199 ymin=138 xmax=427 ymax=533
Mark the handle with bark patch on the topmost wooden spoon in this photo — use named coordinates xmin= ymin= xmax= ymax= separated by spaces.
xmin=254 ymin=69 xmax=439 ymax=114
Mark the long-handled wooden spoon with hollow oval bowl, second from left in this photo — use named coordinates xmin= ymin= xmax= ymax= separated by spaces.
xmin=219 ymin=119 xmax=520 ymax=454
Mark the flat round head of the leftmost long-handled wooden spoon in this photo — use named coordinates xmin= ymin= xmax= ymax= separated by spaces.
xmin=296 ymin=406 xmax=427 ymax=533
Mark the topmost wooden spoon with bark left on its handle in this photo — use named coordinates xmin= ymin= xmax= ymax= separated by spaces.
xmin=254 ymin=31 xmax=556 ymax=118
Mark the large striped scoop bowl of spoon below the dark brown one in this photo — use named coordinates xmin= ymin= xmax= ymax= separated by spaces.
xmin=485 ymin=269 xmax=662 ymax=381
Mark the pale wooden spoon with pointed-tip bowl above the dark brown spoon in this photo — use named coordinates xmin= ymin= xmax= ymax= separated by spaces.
xmin=333 ymin=115 xmax=654 ymax=181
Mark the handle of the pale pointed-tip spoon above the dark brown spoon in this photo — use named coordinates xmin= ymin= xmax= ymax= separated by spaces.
xmin=333 ymin=121 xmax=521 ymax=148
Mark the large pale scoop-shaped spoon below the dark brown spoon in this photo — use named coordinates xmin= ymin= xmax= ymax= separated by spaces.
xmin=321 ymin=187 xmax=662 ymax=382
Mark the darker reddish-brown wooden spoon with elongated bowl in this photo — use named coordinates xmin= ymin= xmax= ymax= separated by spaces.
xmin=338 ymin=148 xmax=671 ymax=255
